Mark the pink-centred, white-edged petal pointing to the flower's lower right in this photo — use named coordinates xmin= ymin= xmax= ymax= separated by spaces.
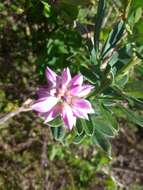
xmin=72 ymin=98 xmax=94 ymax=114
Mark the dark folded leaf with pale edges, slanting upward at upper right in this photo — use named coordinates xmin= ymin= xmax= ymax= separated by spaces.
xmin=102 ymin=20 xmax=125 ymax=58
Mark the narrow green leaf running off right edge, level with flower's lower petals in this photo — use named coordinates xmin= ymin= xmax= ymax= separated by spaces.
xmin=119 ymin=106 xmax=143 ymax=127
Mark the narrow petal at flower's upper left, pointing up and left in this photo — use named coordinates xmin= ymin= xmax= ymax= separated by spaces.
xmin=45 ymin=67 xmax=57 ymax=85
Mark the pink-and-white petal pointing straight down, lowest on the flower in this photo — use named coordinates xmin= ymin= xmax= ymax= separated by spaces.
xmin=61 ymin=105 xmax=76 ymax=130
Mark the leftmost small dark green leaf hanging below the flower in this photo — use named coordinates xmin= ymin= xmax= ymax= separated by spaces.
xmin=51 ymin=126 xmax=65 ymax=140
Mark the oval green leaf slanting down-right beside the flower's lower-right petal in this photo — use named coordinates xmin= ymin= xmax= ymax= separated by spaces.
xmin=100 ymin=104 xmax=118 ymax=131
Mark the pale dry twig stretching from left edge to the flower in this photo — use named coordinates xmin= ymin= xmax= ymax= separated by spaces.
xmin=0 ymin=99 xmax=32 ymax=125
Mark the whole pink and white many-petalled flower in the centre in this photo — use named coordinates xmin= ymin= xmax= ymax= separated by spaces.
xmin=31 ymin=67 xmax=94 ymax=130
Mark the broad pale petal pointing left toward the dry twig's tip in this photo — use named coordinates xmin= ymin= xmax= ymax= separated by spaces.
xmin=31 ymin=96 xmax=58 ymax=113
